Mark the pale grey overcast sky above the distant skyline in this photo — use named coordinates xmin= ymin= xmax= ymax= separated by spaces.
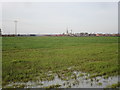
xmin=2 ymin=2 xmax=118 ymax=34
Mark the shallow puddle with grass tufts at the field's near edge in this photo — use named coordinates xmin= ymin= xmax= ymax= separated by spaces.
xmin=5 ymin=71 xmax=118 ymax=88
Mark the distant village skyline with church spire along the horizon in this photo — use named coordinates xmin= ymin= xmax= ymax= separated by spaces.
xmin=0 ymin=29 xmax=120 ymax=37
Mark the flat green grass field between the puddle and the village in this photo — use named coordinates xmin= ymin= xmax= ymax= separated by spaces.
xmin=2 ymin=37 xmax=118 ymax=85
